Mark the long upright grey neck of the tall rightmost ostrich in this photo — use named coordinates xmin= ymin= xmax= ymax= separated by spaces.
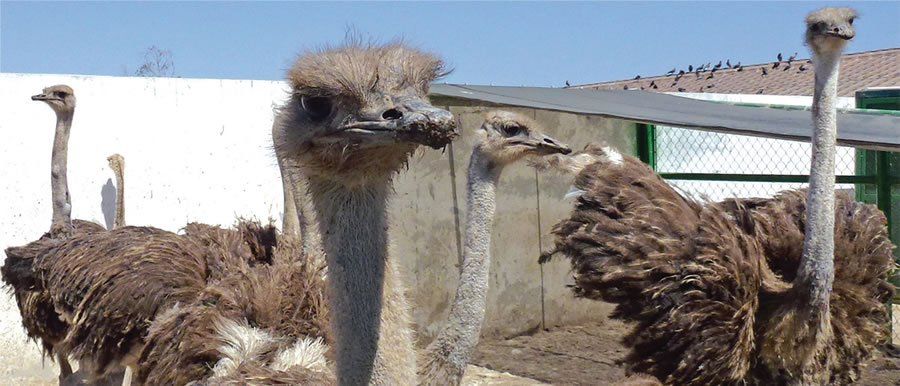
xmin=795 ymin=54 xmax=840 ymax=312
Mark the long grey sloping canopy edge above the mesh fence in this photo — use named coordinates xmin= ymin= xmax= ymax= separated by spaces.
xmin=431 ymin=84 xmax=900 ymax=151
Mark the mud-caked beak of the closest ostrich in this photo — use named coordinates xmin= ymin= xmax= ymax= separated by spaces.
xmin=333 ymin=96 xmax=458 ymax=149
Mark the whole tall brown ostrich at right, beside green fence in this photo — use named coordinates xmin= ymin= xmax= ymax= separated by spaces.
xmin=542 ymin=8 xmax=893 ymax=384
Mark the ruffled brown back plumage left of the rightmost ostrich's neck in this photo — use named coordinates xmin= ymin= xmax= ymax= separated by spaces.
xmin=553 ymin=146 xmax=762 ymax=385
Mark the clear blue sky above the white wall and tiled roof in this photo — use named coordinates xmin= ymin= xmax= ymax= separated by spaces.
xmin=0 ymin=1 xmax=900 ymax=87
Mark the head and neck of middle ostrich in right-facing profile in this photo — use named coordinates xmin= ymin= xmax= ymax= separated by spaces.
xmin=419 ymin=111 xmax=570 ymax=385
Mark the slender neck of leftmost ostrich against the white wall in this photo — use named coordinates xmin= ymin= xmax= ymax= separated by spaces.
xmin=50 ymin=111 xmax=75 ymax=235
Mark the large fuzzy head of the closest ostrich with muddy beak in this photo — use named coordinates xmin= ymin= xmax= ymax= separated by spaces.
xmin=272 ymin=42 xmax=457 ymax=185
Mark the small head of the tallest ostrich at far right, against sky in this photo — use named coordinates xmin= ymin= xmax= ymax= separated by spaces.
xmin=806 ymin=8 xmax=857 ymax=56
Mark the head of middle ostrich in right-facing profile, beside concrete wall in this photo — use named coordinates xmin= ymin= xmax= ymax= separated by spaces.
xmin=476 ymin=111 xmax=572 ymax=165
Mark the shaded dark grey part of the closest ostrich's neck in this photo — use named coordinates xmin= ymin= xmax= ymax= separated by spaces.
xmin=308 ymin=177 xmax=390 ymax=385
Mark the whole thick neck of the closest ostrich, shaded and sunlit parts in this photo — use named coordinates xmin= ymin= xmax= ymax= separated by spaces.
xmin=306 ymin=177 xmax=415 ymax=385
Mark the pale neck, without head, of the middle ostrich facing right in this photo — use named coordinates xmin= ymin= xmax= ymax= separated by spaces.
xmin=422 ymin=147 xmax=502 ymax=383
